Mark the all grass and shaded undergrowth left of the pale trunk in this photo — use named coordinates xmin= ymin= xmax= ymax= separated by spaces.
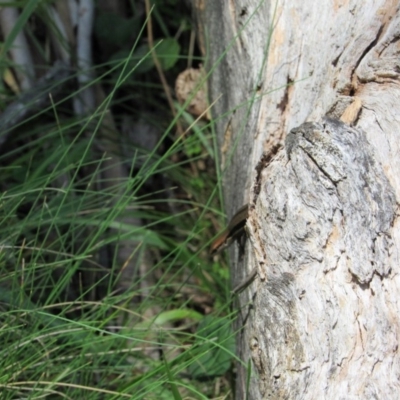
xmin=0 ymin=0 xmax=241 ymax=399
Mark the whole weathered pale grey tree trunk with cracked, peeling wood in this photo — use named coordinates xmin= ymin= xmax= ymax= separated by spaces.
xmin=192 ymin=0 xmax=400 ymax=400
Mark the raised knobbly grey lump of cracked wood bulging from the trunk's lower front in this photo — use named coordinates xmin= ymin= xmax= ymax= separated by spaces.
xmin=246 ymin=120 xmax=400 ymax=399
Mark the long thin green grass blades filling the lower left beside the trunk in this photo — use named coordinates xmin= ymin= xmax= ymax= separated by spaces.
xmin=0 ymin=96 xmax=238 ymax=399
